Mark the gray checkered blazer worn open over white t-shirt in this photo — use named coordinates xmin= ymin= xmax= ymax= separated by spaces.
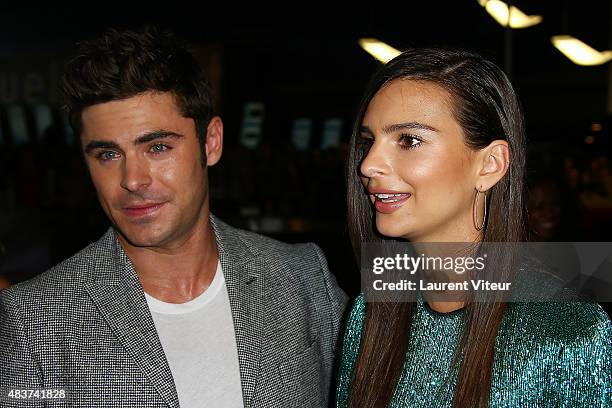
xmin=0 ymin=216 xmax=346 ymax=408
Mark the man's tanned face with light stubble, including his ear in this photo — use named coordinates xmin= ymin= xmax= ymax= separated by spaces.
xmin=81 ymin=92 xmax=223 ymax=249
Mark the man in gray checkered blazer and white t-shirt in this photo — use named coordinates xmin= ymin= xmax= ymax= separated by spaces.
xmin=0 ymin=28 xmax=346 ymax=408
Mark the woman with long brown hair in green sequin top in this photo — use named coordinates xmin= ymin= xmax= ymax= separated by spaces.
xmin=337 ymin=49 xmax=612 ymax=408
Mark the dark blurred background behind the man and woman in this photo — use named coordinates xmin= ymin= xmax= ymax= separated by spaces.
xmin=0 ymin=0 xmax=612 ymax=310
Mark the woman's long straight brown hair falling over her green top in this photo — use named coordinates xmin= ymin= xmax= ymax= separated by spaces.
xmin=347 ymin=49 xmax=525 ymax=408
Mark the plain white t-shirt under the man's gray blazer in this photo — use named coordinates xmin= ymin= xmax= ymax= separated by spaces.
xmin=145 ymin=263 xmax=244 ymax=408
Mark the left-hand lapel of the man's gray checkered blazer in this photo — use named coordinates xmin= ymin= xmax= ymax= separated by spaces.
xmin=86 ymin=231 xmax=179 ymax=408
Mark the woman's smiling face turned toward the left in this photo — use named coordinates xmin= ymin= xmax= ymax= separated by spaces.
xmin=360 ymin=80 xmax=482 ymax=242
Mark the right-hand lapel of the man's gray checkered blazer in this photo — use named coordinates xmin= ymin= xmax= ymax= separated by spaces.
xmin=210 ymin=215 xmax=264 ymax=408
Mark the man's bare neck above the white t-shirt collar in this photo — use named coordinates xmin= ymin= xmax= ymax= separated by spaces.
xmin=120 ymin=219 xmax=219 ymax=303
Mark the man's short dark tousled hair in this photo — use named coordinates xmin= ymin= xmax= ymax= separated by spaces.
xmin=61 ymin=26 xmax=213 ymax=149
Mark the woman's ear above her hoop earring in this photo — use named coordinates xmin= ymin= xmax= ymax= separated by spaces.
xmin=474 ymin=140 xmax=510 ymax=191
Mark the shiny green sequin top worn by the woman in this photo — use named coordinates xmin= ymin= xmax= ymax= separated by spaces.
xmin=336 ymin=296 xmax=612 ymax=408
